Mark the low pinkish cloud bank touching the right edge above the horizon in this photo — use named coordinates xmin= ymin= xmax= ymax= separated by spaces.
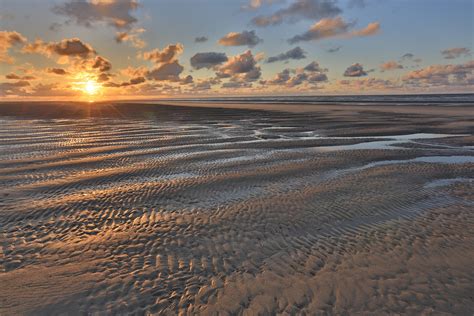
xmin=403 ymin=60 xmax=474 ymax=85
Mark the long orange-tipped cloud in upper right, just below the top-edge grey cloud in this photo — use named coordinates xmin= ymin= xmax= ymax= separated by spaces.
xmin=288 ymin=17 xmax=380 ymax=44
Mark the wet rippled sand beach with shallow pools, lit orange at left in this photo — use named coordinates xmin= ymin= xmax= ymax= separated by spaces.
xmin=0 ymin=104 xmax=474 ymax=315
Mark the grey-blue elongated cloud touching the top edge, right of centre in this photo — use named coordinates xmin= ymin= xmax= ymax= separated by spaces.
xmin=252 ymin=0 xmax=342 ymax=27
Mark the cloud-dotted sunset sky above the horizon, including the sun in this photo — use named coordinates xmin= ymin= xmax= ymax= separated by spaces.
xmin=0 ymin=0 xmax=474 ymax=99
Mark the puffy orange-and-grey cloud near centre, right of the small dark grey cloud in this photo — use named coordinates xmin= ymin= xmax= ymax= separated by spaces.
xmin=217 ymin=50 xmax=261 ymax=81
